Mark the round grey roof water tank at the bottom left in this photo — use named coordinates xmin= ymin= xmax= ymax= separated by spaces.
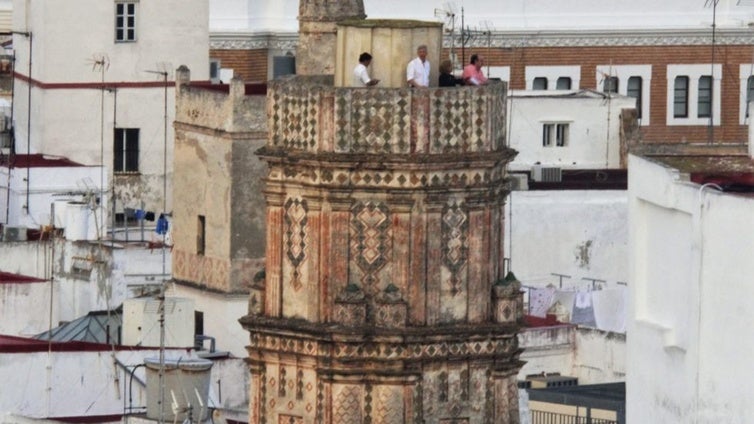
xmin=144 ymin=358 xmax=212 ymax=422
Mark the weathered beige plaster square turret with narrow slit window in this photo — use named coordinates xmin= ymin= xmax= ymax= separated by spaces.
xmin=173 ymin=75 xmax=267 ymax=293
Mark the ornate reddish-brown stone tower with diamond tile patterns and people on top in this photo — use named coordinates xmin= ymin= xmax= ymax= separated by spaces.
xmin=241 ymin=16 xmax=522 ymax=424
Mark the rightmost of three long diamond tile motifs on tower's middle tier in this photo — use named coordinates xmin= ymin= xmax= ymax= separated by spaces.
xmin=442 ymin=200 xmax=469 ymax=296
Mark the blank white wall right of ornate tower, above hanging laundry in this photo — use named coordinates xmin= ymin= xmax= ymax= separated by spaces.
xmin=505 ymin=190 xmax=628 ymax=288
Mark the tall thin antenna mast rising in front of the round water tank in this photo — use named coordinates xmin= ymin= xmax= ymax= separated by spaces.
xmin=144 ymin=63 xmax=169 ymax=424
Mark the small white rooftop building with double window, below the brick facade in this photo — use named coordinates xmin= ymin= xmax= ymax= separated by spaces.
xmin=508 ymin=91 xmax=636 ymax=171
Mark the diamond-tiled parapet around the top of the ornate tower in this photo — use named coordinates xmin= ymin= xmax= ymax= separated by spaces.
xmin=267 ymin=76 xmax=507 ymax=154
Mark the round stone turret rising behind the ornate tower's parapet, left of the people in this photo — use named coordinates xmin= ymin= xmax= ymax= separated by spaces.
xmin=296 ymin=0 xmax=366 ymax=75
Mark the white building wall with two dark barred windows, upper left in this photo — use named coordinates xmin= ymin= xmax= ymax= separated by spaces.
xmin=9 ymin=0 xmax=209 ymax=214
